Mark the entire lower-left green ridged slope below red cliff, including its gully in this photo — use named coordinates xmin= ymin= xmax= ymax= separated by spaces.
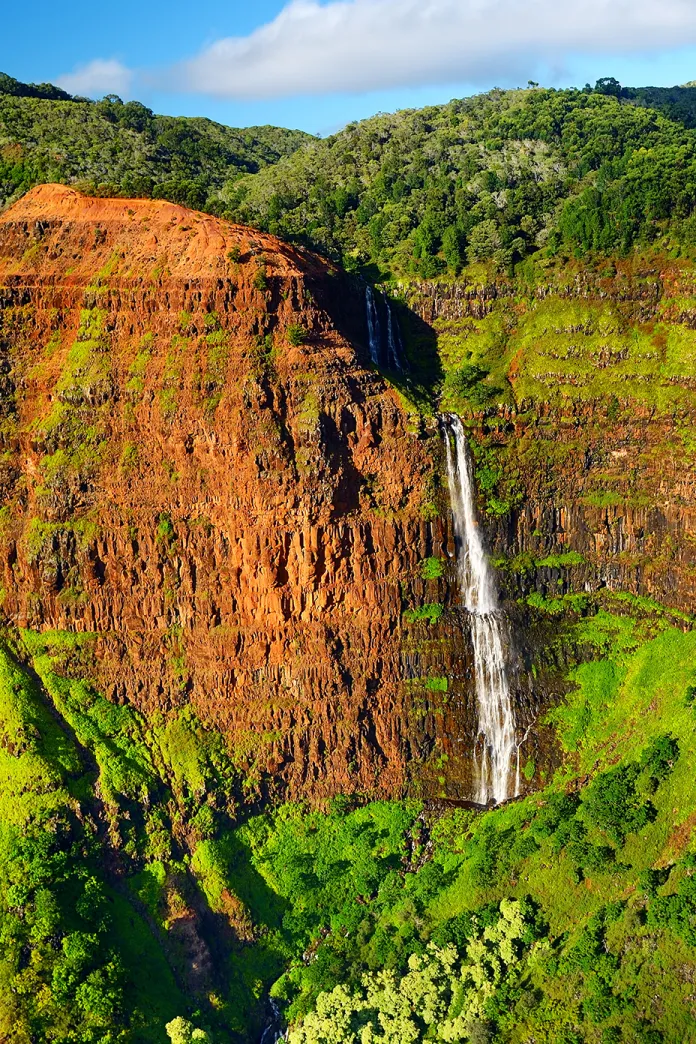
xmin=0 ymin=632 xmax=254 ymax=1044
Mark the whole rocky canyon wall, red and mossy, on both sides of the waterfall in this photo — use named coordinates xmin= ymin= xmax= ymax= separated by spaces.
xmin=6 ymin=186 xmax=696 ymax=800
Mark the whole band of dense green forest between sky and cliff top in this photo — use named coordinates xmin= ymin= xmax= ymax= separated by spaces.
xmin=9 ymin=75 xmax=696 ymax=279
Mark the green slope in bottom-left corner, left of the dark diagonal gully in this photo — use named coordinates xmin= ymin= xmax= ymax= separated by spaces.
xmin=0 ymin=630 xmax=185 ymax=1044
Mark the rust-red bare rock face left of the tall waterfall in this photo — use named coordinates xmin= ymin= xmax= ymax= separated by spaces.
xmin=0 ymin=186 xmax=457 ymax=796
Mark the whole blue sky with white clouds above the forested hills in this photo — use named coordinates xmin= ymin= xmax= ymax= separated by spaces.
xmin=6 ymin=0 xmax=696 ymax=134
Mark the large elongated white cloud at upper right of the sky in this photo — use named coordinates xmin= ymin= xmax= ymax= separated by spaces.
xmin=176 ymin=0 xmax=696 ymax=98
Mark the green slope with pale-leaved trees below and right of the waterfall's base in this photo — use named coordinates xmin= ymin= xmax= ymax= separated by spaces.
xmin=206 ymin=612 xmax=696 ymax=1042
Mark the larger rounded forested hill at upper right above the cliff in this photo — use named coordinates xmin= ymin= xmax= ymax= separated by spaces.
xmin=222 ymin=81 xmax=696 ymax=279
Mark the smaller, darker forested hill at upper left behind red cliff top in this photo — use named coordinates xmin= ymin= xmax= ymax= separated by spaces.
xmin=0 ymin=74 xmax=311 ymax=209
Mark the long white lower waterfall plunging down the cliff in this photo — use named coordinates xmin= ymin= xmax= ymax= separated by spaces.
xmin=445 ymin=414 xmax=520 ymax=805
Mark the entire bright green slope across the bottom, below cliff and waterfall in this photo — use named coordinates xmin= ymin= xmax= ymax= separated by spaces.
xmin=0 ymin=598 xmax=696 ymax=1044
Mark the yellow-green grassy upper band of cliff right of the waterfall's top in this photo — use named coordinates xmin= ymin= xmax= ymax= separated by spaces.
xmin=421 ymin=257 xmax=696 ymax=420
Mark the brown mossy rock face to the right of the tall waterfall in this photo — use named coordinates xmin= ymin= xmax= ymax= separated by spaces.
xmin=407 ymin=273 xmax=696 ymax=613
